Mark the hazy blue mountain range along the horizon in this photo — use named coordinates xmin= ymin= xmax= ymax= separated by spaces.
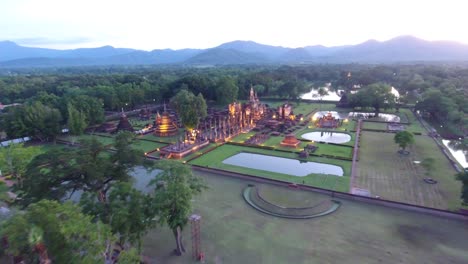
xmin=0 ymin=36 xmax=468 ymax=68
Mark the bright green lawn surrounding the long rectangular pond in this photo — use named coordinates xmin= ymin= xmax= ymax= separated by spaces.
xmin=190 ymin=145 xmax=351 ymax=192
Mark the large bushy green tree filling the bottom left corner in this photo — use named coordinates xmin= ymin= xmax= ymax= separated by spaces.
xmin=0 ymin=200 xmax=115 ymax=263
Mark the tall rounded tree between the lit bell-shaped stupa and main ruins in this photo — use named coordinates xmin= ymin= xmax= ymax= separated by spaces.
xmin=171 ymin=90 xmax=207 ymax=131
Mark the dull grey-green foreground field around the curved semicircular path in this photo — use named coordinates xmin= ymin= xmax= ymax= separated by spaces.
xmin=143 ymin=173 xmax=468 ymax=264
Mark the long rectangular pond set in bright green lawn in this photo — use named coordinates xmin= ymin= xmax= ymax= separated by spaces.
xmin=223 ymin=152 xmax=343 ymax=177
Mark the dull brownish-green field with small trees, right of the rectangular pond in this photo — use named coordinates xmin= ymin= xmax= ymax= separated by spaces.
xmin=356 ymin=131 xmax=461 ymax=209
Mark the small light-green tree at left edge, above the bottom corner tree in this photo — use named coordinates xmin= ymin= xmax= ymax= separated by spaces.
xmin=0 ymin=143 xmax=41 ymax=185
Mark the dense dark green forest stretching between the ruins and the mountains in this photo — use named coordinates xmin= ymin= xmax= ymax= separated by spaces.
xmin=0 ymin=64 xmax=468 ymax=140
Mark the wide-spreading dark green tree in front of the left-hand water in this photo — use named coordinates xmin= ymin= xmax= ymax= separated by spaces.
xmin=15 ymin=132 xmax=144 ymax=205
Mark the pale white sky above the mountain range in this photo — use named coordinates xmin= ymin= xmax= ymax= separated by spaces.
xmin=0 ymin=0 xmax=468 ymax=50
